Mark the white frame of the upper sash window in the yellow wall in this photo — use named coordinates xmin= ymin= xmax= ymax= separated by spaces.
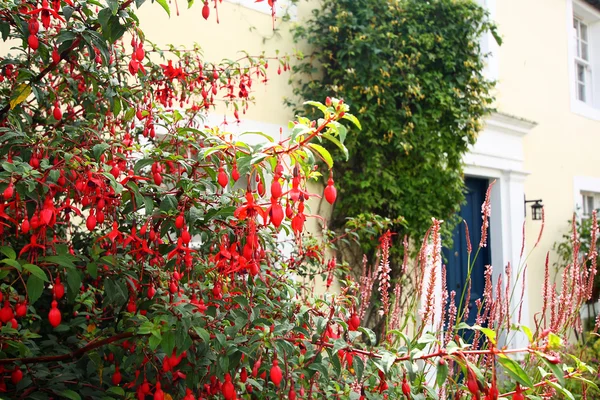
xmin=567 ymin=0 xmax=600 ymax=121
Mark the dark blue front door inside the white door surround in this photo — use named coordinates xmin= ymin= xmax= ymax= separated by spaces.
xmin=444 ymin=178 xmax=491 ymax=325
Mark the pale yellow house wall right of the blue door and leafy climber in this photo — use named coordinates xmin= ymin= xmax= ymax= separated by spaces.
xmin=496 ymin=0 xmax=600 ymax=324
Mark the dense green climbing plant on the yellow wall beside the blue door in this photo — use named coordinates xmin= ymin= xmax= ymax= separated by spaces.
xmin=289 ymin=0 xmax=500 ymax=260
